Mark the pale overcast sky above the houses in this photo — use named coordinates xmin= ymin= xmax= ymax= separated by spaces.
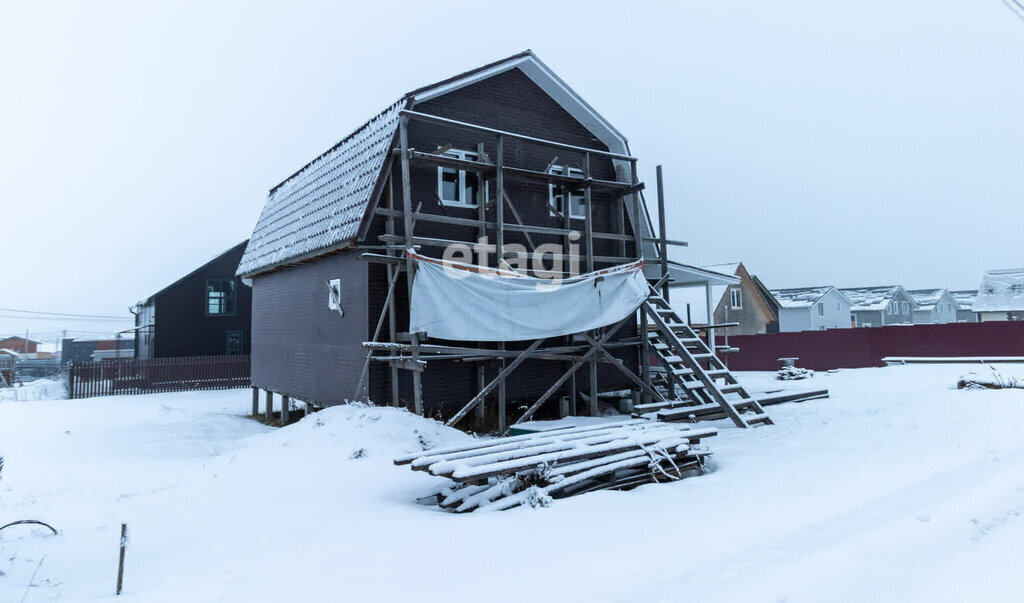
xmin=0 ymin=0 xmax=1024 ymax=341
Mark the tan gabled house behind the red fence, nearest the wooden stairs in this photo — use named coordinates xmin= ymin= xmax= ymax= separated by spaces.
xmin=672 ymin=262 xmax=778 ymax=336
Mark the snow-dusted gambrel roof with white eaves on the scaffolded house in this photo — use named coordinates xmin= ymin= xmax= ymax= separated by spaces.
xmin=238 ymin=50 xmax=634 ymax=276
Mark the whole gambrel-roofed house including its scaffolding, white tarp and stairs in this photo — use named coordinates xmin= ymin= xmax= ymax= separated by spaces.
xmin=238 ymin=51 xmax=769 ymax=432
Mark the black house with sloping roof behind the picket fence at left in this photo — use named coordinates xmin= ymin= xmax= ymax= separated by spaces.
xmin=133 ymin=242 xmax=252 ymax=358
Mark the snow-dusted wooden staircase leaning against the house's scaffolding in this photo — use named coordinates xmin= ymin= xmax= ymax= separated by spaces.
xmin=636 ymin=287 xmax=772 ymax=428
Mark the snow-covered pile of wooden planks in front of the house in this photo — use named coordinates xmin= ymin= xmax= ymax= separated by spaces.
xmin=394 ymin=419 xmax=718 ymax=513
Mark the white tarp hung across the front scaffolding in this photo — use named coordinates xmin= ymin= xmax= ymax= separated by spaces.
xmin=410 ymin=252 xmax=648 ymax=341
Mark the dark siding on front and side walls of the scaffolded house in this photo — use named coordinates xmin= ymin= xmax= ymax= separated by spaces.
xmin=252 ymin=64 xmax=638 ymax=416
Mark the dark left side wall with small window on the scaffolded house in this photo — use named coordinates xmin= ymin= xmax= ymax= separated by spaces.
xmin=252 ymin=248 xmax=369 ymax=405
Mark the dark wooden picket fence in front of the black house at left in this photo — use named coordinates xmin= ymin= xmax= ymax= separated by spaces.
xmin=68 ymin=355 xmax=250 ymax=398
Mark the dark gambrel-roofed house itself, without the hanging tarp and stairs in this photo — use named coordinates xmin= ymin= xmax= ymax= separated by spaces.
xmin=238 ymin=51 xmax=761 ymax=429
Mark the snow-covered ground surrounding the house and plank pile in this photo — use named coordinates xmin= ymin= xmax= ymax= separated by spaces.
xmin=0 ymin=364 xmax=1024 ymax=602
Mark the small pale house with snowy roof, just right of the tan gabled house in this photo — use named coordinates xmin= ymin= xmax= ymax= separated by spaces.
xmin=771 ymin=286 xmax=853 ymax=333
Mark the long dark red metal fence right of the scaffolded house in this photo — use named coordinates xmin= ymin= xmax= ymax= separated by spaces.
xmin=729 ymin=321 xmax=1024 ymax=371
